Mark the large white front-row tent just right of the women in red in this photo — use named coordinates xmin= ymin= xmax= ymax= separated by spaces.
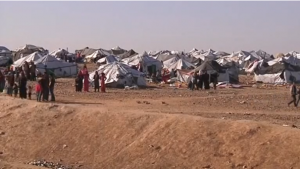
xmin=89 ymin=62 xmax=146 ymax=87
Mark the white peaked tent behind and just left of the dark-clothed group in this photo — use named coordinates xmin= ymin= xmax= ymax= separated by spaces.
xmin=163 ymin=56 xmax=196 ymax=71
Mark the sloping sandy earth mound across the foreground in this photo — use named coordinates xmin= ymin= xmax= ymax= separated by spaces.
xmin=0 ymin=98 xmax=300 ymax=169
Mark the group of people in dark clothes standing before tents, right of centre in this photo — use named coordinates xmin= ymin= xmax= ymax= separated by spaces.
xmin=188 ymin=71 xmax=218 ymax=91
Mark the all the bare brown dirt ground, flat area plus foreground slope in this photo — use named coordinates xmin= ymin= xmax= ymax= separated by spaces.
xmin=0 ymin=63 xmax=300 ymax=169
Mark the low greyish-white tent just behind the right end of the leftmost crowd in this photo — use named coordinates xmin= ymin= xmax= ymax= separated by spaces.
xmin=35 ymin=55 xmax=78 ymax=77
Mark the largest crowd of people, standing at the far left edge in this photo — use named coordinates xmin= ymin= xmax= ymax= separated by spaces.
xmin=0 ymin=62 xmax=55 ymax=101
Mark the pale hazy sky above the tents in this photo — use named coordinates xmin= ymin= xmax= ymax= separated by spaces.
xmin=0 ymin=2 xmax=300 ymax=54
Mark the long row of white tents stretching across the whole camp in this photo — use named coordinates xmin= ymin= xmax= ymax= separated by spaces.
xmin=0 ymin=45 xmax=300 ymax=84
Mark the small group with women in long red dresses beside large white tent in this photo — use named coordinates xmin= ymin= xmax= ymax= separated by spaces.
xmin=75 ymin=65 xmax=106 ymax=92
